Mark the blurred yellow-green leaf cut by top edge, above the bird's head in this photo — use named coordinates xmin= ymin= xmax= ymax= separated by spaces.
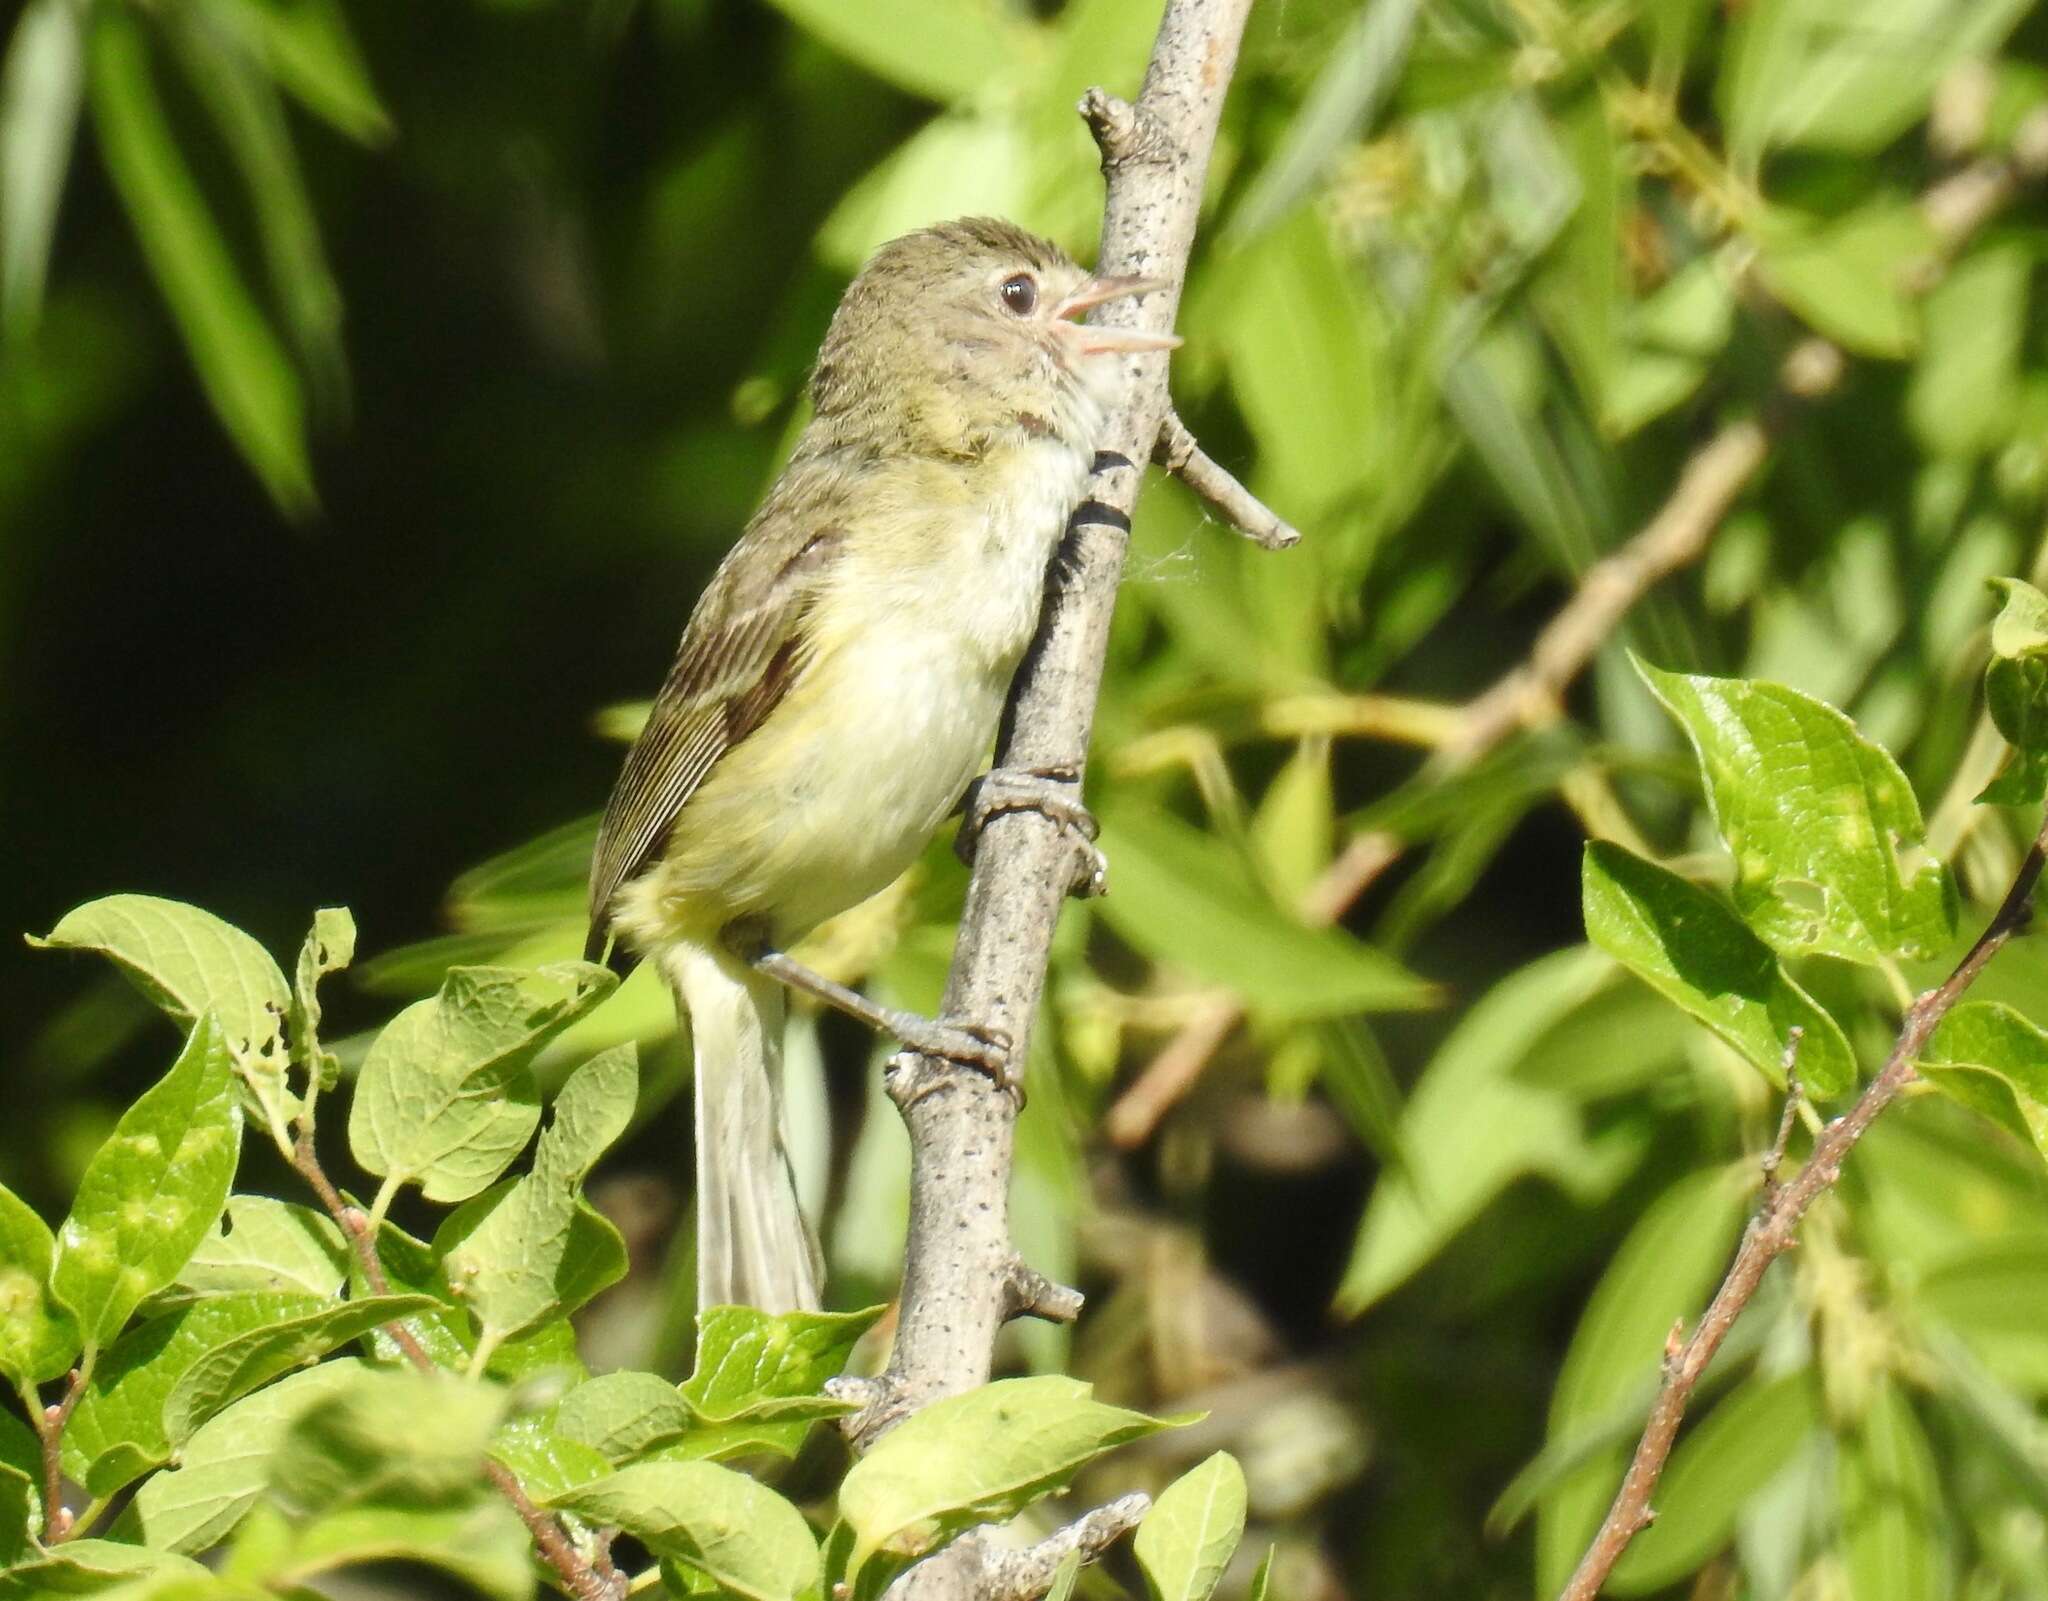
xmin=753 ymin=0 xmax=1040 ymax=100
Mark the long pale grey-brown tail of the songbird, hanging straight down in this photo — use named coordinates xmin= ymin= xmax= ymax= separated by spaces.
xmin=664 ymin=946 xmax=823 ymax=1312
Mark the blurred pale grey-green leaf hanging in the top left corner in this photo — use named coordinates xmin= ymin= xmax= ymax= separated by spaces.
xmin=0 ymin=0 xmax=84 ymax=334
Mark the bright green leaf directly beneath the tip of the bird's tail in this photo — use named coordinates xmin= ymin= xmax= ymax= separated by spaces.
xmin=680 ymin=1306 xmax=889 ymax=1423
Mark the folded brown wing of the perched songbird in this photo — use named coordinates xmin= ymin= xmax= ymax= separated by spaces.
xmin=584 ymin=524 xmax=842 ymax=962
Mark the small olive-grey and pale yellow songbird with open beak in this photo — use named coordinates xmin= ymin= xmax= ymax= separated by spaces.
xmin=588 ymin=219 xmax=1180 ymax=1312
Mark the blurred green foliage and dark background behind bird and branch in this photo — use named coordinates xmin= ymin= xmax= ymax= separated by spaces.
xmin=0 ymin=0 xmax=2048 ymax=1601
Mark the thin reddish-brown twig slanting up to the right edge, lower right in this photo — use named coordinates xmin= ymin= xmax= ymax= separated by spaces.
xmin=1559 ymin=821 xmax=2048 ymax=1601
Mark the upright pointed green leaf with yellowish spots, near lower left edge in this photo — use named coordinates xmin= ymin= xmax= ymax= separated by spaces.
xmin=49 ymin=1013 xmax=242 ymax=1351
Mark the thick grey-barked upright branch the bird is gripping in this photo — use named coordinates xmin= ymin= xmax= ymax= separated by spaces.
xmin=850 ymin=0 xmax=1251 ymax=1445
